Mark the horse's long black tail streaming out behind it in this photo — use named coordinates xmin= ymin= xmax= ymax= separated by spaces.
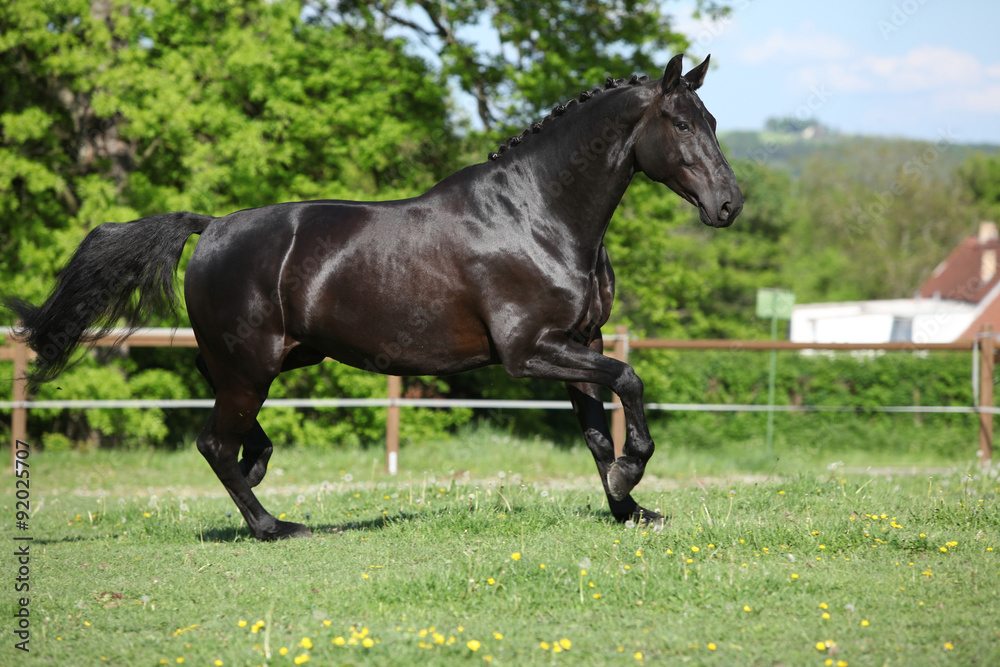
xmin=3 ymin=212 xmax=213 ymax=391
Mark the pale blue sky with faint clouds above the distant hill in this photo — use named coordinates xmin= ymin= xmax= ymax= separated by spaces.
xmin=680 ymin=0 xmax=1000 ymax=144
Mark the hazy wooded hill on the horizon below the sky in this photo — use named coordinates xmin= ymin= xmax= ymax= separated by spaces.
xmin=719 ymin=131 xmax=1000 ymax=175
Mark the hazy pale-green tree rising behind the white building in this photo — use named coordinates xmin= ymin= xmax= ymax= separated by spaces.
xmin=785 ymin=140 xmax=972 ymax=303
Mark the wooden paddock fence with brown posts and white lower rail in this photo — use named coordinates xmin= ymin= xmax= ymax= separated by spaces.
xmin=0 ymin=325 xmax=1000 ymax=474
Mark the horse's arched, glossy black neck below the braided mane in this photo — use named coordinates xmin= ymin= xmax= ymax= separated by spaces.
xmin=494 ymin=89 xmax=645 ymax=242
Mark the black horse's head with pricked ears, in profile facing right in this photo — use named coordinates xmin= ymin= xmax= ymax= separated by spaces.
xmin=635 ymin=55 xmax=743 ymax=227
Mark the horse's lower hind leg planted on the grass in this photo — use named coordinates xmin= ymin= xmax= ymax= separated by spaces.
xmin=198 ymin=387 xmax=311 ymax=541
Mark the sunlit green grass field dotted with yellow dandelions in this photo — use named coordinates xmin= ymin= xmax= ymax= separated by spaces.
xmin=0 ymin=431 xmax=1000 ymax=665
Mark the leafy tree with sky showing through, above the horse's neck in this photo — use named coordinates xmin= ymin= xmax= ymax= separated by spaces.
xmin=318 ymin=0 xmax=728 ymax=130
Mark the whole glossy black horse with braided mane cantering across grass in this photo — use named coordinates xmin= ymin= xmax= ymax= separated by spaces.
xmin=5 ymin=55 xmax=743 ymax=540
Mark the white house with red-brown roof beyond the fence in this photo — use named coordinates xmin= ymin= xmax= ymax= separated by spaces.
xmin=790 ymin=222 xmax=1000 ymax=343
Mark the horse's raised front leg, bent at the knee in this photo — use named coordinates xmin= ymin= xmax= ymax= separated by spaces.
xmin=505 ymin=332 xmax=654 ymax=502
